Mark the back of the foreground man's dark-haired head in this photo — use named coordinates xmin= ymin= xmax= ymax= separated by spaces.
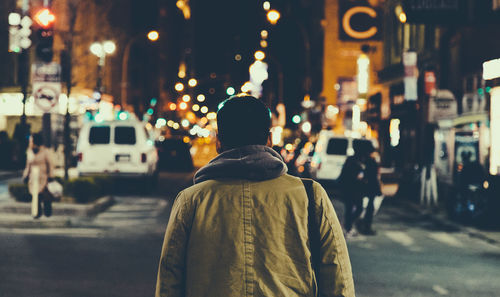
xmin=217 ymin=95 xmax=271 ymax=149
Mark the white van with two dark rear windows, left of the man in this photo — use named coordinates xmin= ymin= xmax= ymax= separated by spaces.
xmin=76 ymin=120 xmax=158 ymax=177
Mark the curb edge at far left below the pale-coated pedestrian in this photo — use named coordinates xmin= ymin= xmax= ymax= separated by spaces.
xmin=0 ymin=196 xmax=115 ymax=228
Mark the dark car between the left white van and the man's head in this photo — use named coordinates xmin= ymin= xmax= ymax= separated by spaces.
xmin=156 ymin=138 xmax=194 ymax=171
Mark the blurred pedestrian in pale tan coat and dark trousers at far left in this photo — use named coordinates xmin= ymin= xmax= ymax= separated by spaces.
xmin=23 ymin=133 xmax=53 ymax=219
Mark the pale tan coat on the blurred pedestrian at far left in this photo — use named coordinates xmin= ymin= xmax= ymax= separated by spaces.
xmin=23 ymin=146 xmax=53 ymax=195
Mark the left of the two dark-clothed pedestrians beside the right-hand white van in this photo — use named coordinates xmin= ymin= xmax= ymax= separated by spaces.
xmin=338 ymin=145 xmax=371 ymax=238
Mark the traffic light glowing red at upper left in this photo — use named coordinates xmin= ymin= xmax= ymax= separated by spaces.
xmin=34 ymin=8 xmax=56 ymax=62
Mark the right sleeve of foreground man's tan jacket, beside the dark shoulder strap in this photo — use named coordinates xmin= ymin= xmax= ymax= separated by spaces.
xmin=313 ymin=182 xmax=355 ymax=297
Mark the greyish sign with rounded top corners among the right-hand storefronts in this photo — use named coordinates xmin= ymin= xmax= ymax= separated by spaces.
xmin=429 ymin=90 xmax=457 ymax=123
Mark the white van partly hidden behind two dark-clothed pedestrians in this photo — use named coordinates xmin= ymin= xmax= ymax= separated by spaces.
xmin=311 ymin=130 xmax=378 ymax=181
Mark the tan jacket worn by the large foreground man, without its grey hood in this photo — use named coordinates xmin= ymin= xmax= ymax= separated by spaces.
xmin=156 ymin=145 xmax=355 ymax=297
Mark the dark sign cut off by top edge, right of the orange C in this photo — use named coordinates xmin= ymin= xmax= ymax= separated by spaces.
xmin=403 ymin=0 xmax=466 ymax=24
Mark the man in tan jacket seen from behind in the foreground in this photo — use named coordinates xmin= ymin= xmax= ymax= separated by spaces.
xmin=156 ymin=95 xmax=355 ymax=297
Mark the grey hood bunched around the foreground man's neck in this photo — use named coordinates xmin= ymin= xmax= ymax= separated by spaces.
xmin=194 ymin=145 xmax=288 ymax=184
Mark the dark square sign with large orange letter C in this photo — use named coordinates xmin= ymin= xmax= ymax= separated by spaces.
xmin=339 ymin=0 xmax=382 ymax=41
